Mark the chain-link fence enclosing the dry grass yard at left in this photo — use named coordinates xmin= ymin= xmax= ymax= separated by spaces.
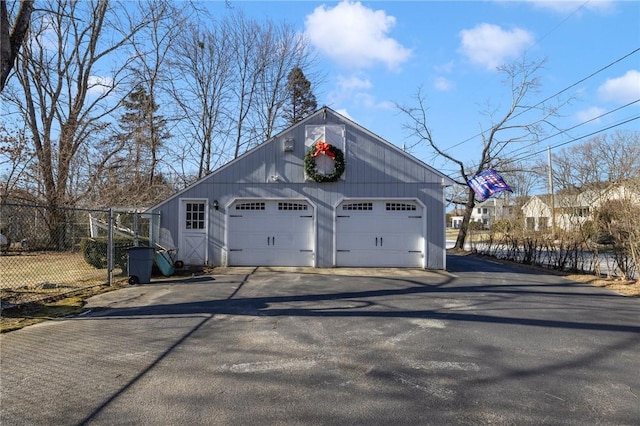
xmin=0 ymin=203 xmax=159 ymax=308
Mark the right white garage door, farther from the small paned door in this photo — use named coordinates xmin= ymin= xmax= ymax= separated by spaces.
xmin=336 ymin=200 xmax=424 ymax=267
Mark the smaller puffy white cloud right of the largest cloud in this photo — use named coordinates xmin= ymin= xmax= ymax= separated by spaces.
xmin=459 ymin=23 xmax=534 ymax=70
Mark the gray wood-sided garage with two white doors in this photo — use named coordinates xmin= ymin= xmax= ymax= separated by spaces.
xmin=148 ymin=107 xmax=454 ymax=269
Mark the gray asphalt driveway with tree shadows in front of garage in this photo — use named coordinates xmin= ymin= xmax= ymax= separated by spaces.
xmin=0 ymin=256 xmax=640 ymax=425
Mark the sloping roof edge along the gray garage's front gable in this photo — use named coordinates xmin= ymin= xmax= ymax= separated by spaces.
xmin=148 ymin=106 xmax=455 ymax=211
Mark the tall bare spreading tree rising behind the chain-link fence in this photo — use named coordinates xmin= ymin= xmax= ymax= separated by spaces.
xmin=3 ymin=0 xmax=158 ymax=246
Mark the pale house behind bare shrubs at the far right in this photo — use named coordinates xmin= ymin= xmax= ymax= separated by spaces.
xmin=522 ymin=184 xmax=640 ymax=231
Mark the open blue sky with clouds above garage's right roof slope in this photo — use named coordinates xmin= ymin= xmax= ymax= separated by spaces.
xmin=208 ymin=0 xmax=640 ymax=174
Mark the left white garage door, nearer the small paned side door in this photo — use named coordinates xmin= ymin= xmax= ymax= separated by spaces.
xmin=227 ymin=200 xmax=315 ymax=266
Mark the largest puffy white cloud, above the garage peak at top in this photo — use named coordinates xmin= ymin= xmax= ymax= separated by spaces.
xmin=305 ymin=0 xmax=411 ymax=69
